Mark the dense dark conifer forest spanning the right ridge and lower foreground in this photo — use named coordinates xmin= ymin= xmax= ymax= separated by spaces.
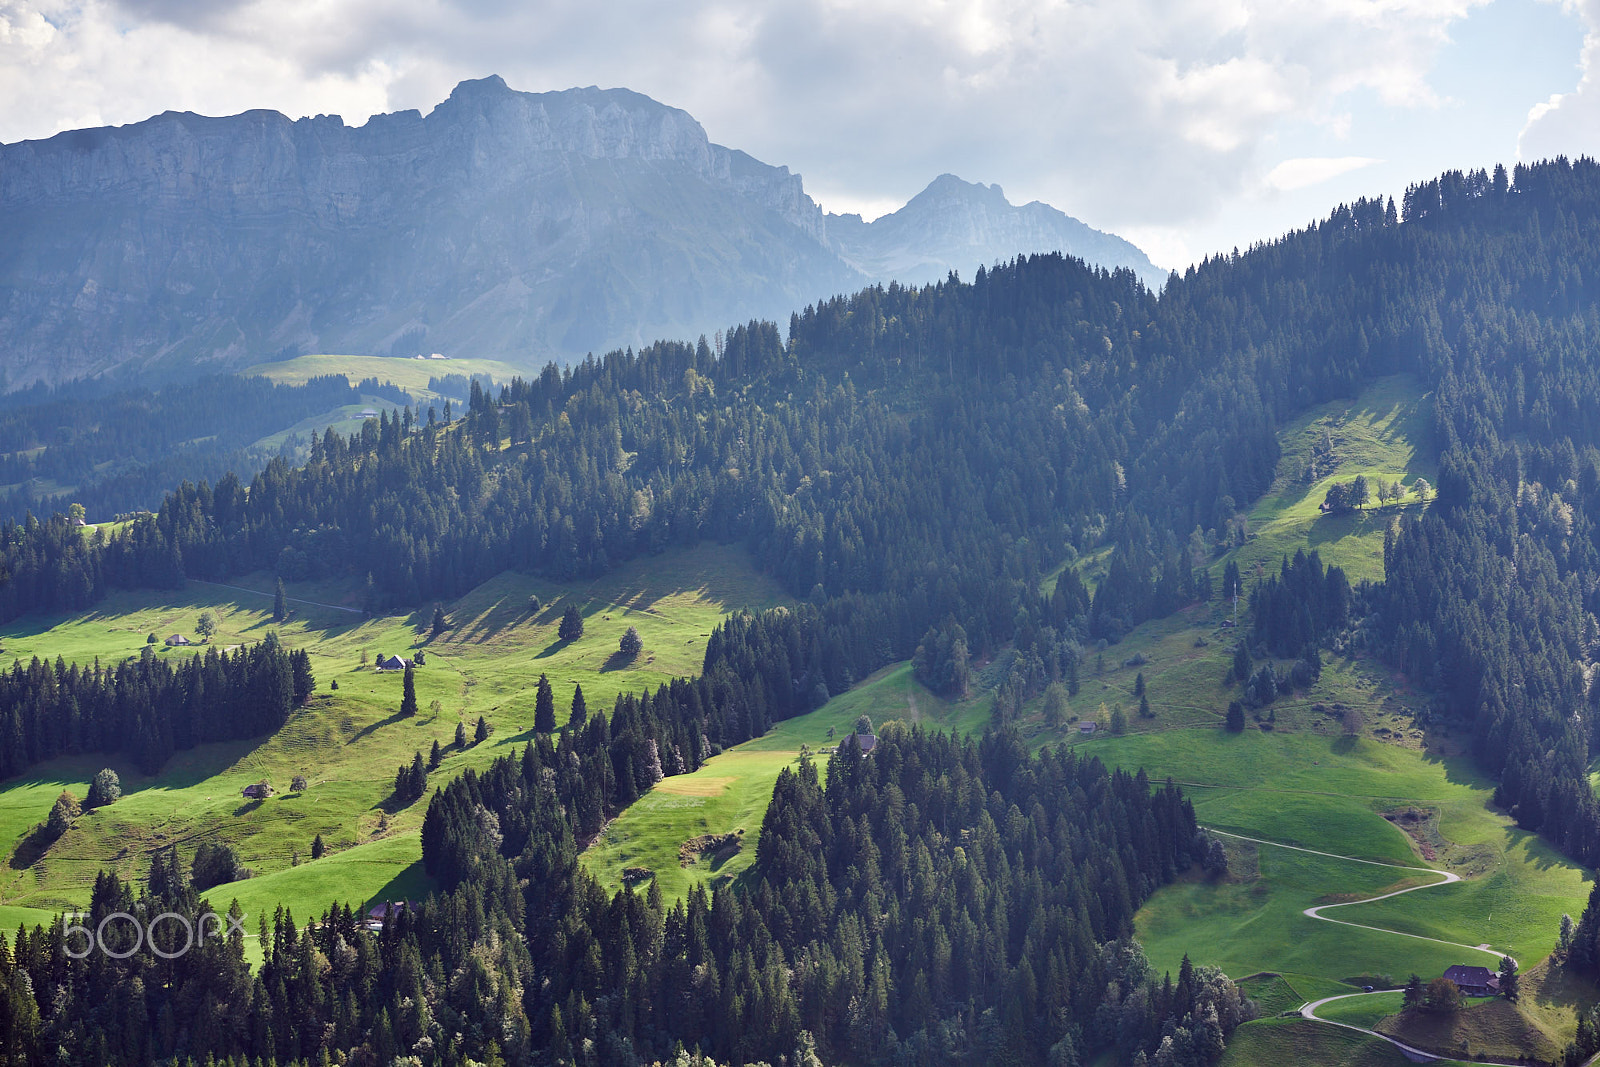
xmin=0 ymin=160 xmax=1600 ymax=1067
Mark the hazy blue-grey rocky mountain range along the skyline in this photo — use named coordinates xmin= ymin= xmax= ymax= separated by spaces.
xmin=0 ymin=77 xmax=1165 ymax=389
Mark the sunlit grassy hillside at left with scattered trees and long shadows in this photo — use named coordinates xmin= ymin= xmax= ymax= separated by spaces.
xmin=0 ymin=545 xmax=782 ymax=915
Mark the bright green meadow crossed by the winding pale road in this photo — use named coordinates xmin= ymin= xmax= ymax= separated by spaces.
xmin=1085 ymin=729 xmax=1589 ymax=981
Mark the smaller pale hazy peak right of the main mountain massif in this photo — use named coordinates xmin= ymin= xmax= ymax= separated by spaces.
xmin=827 ymin=174 xmax=1166 ymax=290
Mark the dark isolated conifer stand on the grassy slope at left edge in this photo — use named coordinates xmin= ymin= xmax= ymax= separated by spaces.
xmin=0 ymin=633 xmax=315 ymax=777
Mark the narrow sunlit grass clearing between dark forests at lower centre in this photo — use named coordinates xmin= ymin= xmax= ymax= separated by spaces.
xmin=582 ymin=664 xmax=989 ymax=899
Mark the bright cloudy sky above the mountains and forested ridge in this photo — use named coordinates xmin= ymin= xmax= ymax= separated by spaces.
xmin=0 ymin=0 xmax=1600 ymax=269
